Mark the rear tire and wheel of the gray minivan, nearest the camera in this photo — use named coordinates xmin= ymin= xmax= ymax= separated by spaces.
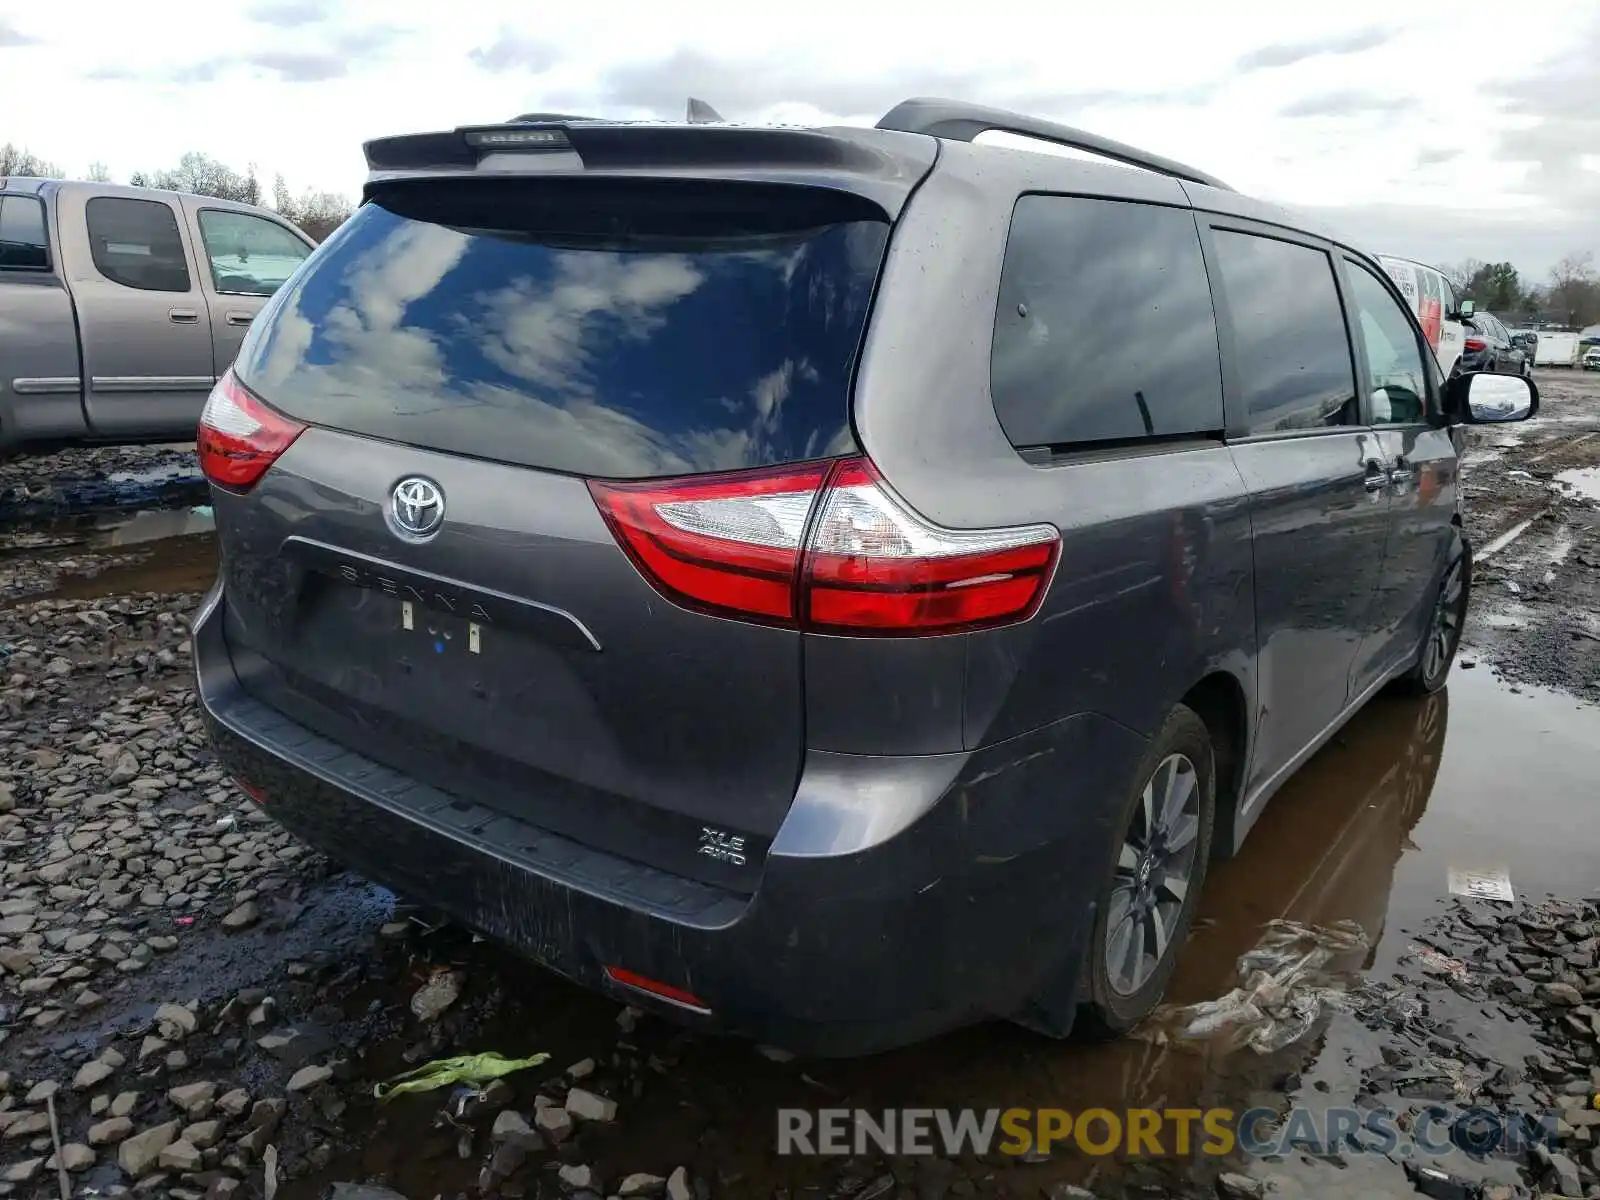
xmin=1075 ymin=704 xmax=1216 ymax=1038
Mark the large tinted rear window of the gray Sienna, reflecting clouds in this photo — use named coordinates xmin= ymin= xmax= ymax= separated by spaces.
xmin=238 ymin=181 xmax=888 ymax=478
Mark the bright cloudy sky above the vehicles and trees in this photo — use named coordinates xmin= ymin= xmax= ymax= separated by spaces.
xmin=0 ymin=0 xmax=1600 ymax=277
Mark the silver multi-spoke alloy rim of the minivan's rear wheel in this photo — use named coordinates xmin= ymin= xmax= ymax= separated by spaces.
xmin=1106 ymin=754 xmax=1200 ymax=995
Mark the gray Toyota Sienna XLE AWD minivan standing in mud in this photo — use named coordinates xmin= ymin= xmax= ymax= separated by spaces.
xmin=194 ymin=101 xmax=1538 ymax=1054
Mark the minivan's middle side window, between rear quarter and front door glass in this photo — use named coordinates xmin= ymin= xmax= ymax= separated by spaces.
xmin=1216 ymin=229 xmax=1360 ymax=434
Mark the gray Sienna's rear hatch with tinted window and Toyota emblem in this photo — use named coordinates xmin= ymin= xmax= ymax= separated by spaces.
xmin=216 ymin=162 xmax=890 ymax=890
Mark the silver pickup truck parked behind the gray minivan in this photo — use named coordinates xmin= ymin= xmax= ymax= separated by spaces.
xmin=0 ymin=178 xmax=314 ymax=453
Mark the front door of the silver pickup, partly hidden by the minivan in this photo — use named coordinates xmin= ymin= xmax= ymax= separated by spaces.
xmin=182 ymin=195 xmax=314 ymax=374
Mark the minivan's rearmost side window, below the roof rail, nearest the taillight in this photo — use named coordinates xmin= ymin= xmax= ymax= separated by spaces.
xmin=990 ymin=195 xmax=1222 ymax=446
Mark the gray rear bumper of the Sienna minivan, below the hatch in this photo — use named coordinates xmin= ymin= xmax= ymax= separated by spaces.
xmin=194 ymin=590 xmax=1144 ymax=1056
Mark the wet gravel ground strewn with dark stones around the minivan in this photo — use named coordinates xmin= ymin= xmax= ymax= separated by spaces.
xmin=0 ymin=395 xmax=1600 ymax=1200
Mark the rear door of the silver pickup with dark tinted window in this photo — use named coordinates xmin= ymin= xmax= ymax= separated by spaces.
xmin=58 ymin=187 xmax=216 ymax=438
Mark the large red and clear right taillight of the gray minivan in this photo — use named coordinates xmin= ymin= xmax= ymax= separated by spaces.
xmin=589 ymin=458 xmax=1061 ymax=637
